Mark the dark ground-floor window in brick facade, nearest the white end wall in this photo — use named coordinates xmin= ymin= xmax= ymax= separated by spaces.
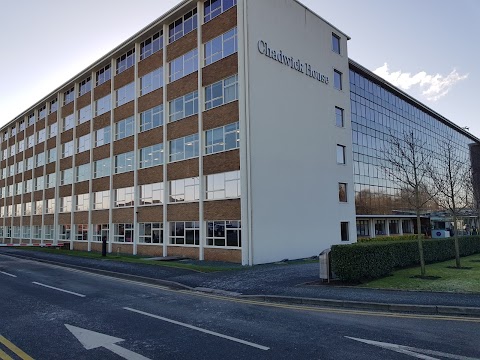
xmin=207 ymin=221 xmax=242 ymax=248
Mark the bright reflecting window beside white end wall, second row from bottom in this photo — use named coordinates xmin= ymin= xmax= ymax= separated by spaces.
xmin=206 ymin=170 xmax=241 ymax=200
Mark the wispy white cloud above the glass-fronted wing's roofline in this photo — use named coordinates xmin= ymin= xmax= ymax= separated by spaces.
xmin=373 ymin=63 xmax=468 ymax=101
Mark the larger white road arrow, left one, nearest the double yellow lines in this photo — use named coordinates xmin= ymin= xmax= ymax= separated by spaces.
xmin=65 ymin=324 xmax=150 ymax=360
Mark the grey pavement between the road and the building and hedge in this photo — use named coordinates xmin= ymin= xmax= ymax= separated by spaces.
xmin=0 ymin=248 xmax=480 ymax=317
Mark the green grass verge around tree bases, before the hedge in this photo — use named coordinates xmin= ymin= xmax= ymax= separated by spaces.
xmin=361 ymin=254 xmax=480 ymax=293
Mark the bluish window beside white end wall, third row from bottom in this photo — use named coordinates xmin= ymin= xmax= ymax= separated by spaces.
xmin=205 ymin=122 xmax=240 ymax=154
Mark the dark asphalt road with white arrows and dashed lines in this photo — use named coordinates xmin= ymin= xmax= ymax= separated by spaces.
xmin=0 ymin=255 xmax=480 ymax=360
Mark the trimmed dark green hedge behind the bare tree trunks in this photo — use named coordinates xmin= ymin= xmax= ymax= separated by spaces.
xmin=330 ymin=236 xmax=480 ymax=282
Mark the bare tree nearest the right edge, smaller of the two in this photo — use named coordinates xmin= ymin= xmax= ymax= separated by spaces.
xmin=430 ymin=139 xmax=471 ymax=268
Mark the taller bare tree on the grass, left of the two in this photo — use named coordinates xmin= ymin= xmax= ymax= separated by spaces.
xmin=383 ymin=131 xmax=433 ymax=276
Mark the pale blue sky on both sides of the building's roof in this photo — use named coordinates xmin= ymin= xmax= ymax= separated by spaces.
xmin=0 ymin=0 xmax=480 ymax=137
